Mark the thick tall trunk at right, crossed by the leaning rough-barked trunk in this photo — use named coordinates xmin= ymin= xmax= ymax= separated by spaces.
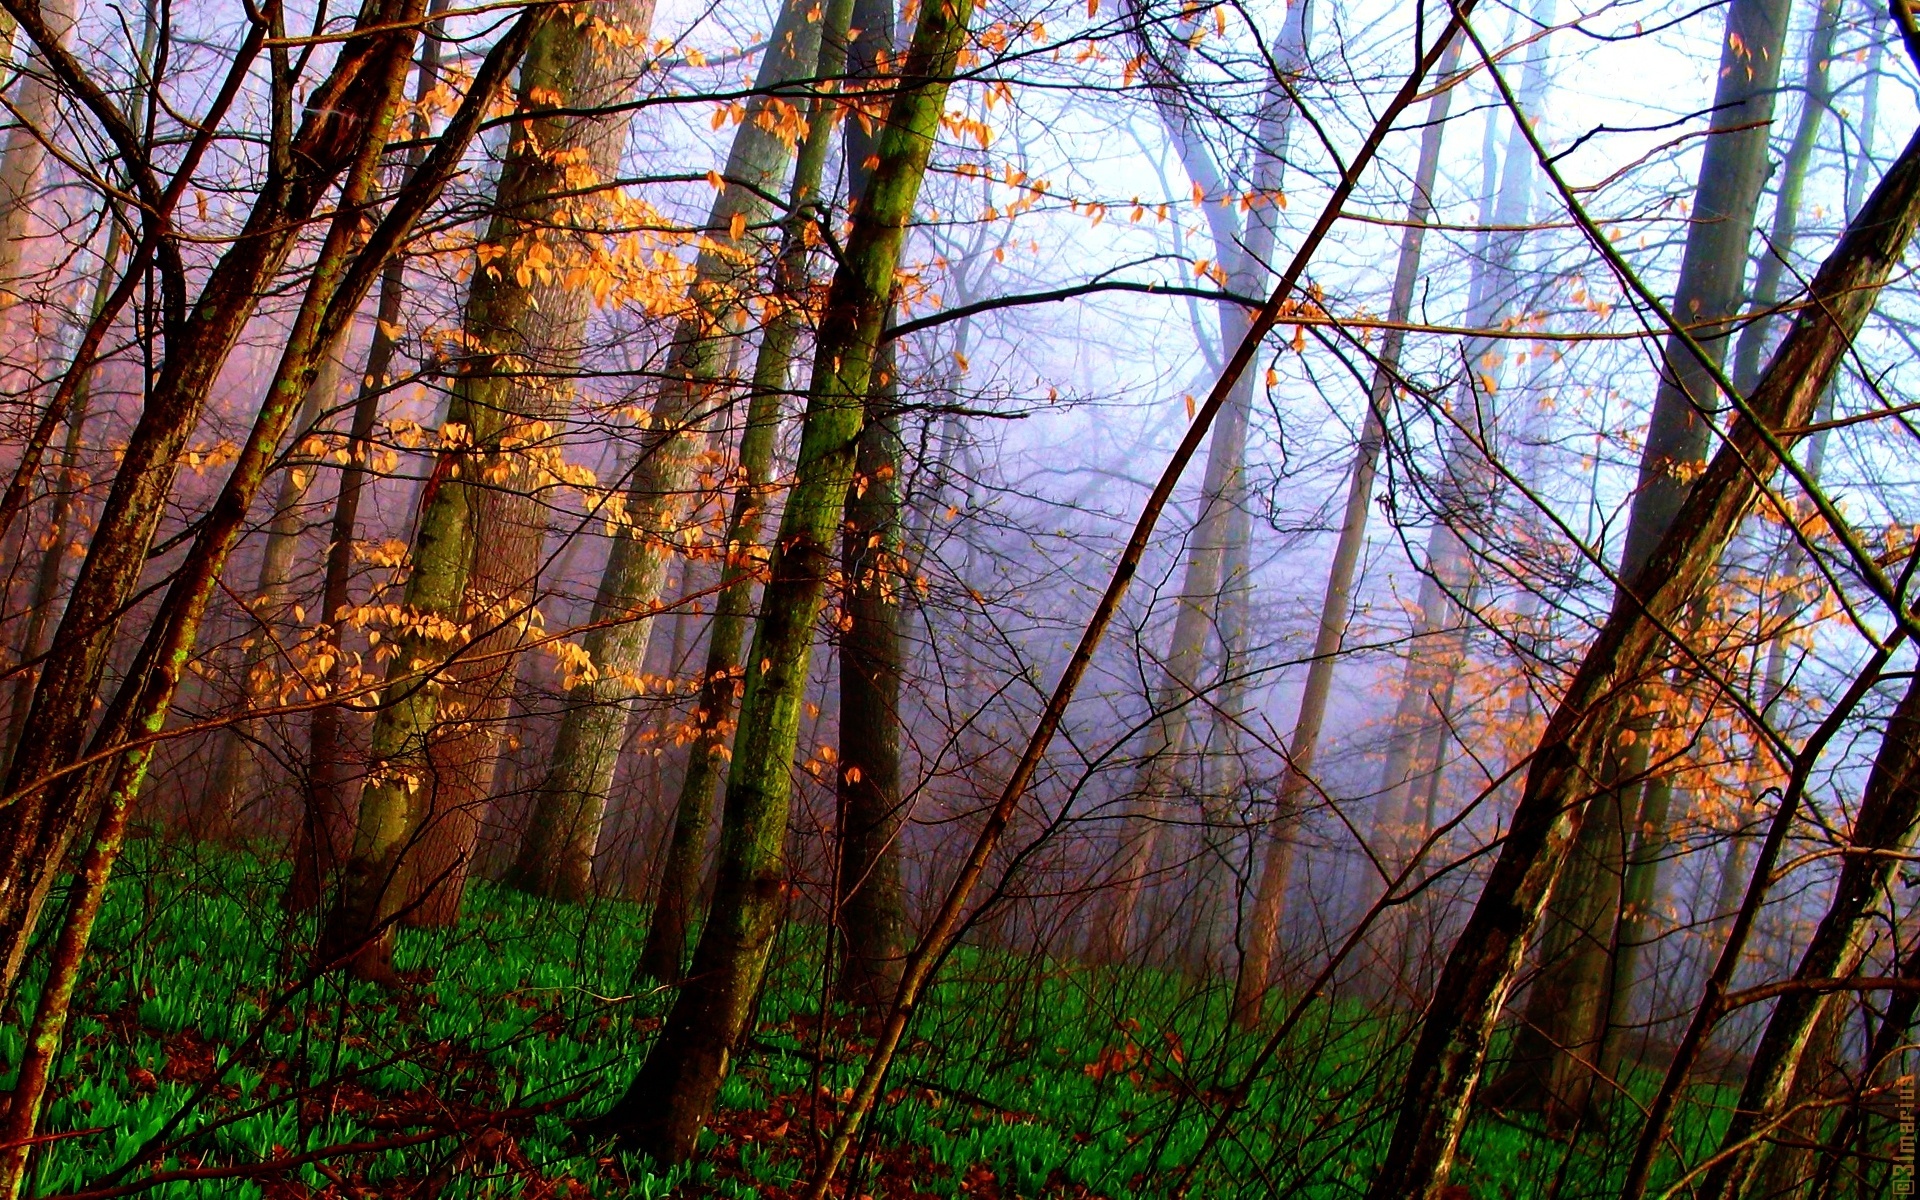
xmin=1500 ymin=0 xmax=1789 ymax=1125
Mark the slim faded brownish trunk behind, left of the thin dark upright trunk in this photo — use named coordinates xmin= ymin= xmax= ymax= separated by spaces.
xmin=190 ymin=348 xmax=346 ymax=841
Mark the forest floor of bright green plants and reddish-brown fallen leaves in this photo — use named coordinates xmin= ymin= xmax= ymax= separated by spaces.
xmin=11 ymin=841 xmax=1728 ymax=1200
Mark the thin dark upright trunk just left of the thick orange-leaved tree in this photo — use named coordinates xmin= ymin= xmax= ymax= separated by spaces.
xmin=286 ymin=0 xmax=451 ymax=912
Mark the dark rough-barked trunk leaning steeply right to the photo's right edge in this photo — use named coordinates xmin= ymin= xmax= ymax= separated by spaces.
xmin=1367 ymin=105 xmax=1920 ymax=1200
